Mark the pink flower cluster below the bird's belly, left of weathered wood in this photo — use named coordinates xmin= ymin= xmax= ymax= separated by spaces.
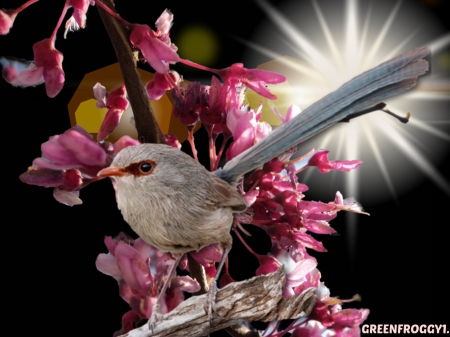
xmin=96 ymin=233 xmax=200 ymax=336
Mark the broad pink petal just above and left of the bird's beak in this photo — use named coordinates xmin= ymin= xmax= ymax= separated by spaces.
xmin=58 ymin=130 xmax=106 ymax=166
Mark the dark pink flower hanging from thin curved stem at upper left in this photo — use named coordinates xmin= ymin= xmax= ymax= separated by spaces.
xmin=33 ymin=39 xmax=64 ymax=98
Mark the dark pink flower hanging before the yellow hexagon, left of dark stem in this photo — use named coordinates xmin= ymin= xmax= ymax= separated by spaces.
xmin=94 ymin=83 xmax=130 ymax=141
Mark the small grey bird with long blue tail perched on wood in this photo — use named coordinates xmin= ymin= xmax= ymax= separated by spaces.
xmin=98 ymin=47 xmax=429 ymax=328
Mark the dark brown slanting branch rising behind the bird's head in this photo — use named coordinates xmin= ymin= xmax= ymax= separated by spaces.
xmin=96 ymin=0 xmax=165 ymax=144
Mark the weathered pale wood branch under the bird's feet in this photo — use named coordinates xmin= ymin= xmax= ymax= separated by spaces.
xmin=123 ymin=268 xmax=316 ymax=337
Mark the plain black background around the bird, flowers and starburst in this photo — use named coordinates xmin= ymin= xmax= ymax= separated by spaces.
xmin=0 ymin=0 xmax=450 ymax=336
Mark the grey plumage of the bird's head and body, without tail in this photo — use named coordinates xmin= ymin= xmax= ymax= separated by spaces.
xmin=111 ymin=144 xmax=246 ymax=253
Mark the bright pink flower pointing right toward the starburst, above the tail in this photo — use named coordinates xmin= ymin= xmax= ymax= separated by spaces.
xmin=217 ymin=63 xmax=286 ymax=100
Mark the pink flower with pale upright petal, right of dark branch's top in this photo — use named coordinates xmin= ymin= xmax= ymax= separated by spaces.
xmin=130 ymin=9 xmax=179 ymax=74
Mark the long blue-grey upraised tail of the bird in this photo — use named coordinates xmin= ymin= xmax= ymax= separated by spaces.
xmin=215 ymin=47 xmax=429 ymax=185
